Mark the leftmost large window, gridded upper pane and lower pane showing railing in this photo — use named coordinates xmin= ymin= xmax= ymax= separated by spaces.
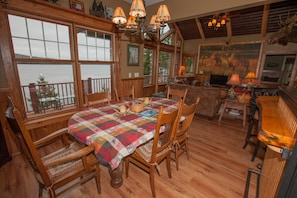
xmin=8 ymin=15 xmax=75 ymax=114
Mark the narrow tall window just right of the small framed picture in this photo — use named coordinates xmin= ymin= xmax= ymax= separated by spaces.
xmin=143 ymin=48 xmax=153 ymax=86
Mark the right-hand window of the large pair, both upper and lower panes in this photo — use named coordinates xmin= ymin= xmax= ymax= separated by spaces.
xmin=77 ymin=28 xmax=112 ymax=103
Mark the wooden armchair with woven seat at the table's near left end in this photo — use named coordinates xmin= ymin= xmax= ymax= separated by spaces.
xmin=5 ymin=98 xmax=101 ymax=198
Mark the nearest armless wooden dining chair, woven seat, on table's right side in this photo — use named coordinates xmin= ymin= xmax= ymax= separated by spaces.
xmin=125 ymin=100 xmax=182 ymax=197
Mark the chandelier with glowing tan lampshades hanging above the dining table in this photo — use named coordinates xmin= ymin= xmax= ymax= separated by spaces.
xmin=112 ymin=0 xmax=170 ymax=33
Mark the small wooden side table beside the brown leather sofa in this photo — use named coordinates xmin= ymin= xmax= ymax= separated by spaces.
xmin=219 ymin=99 xmax=248 ymax=127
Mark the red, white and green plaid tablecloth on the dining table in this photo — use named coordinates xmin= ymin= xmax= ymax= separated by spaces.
xmin=68 ymin=98 xmax=177 ymax=169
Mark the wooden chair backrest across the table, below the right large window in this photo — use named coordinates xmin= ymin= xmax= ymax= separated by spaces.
xmin=87 ymin=91 xmax=111 ymax=107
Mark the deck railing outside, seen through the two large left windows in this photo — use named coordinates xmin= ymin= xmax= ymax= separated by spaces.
xmin=21 ymin=78 xmax=111 ymax=113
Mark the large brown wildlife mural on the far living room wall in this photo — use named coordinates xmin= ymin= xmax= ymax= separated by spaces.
xmin=198 ymin=42 xmax=262 ymax=78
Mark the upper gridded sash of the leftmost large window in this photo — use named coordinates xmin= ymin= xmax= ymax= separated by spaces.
xmin=9 ymin=15 xmax=70 ymax=60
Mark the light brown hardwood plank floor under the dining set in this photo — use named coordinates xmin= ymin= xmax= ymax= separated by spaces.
xmin=0 ymin=117 xmax=264 ymax=198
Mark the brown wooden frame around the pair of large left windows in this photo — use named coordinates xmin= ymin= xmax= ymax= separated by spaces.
xmin=6 ymin=11 xmax=116 ymax=119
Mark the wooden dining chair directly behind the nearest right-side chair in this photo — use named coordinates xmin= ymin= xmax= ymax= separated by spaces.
xmin=172 ymin=97 xmax=200 ymax=170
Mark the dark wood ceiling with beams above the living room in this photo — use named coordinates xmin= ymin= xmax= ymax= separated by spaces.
xmin=174 ymin=0 xmax=297 ymax=41
